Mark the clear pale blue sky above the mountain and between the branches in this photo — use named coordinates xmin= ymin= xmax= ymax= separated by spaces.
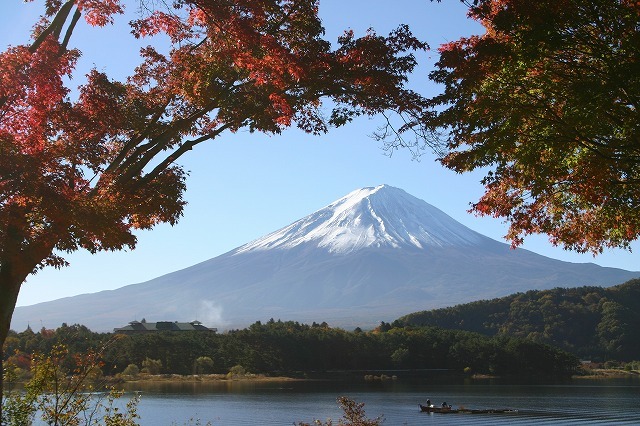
xmin=0 ymin=0 xmax=640 ymax=306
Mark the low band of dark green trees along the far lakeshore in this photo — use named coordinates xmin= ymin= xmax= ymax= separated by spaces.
xmin=4 ymin=320 xmax=578 ymax=376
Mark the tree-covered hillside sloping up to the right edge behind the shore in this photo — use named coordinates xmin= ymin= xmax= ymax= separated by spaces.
xmin=393 ymin=279 xmax=640 ymax=361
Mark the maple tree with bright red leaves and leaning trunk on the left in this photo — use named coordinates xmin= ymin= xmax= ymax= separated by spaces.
xmin=0 ymin=0 xmax=427 ymax=408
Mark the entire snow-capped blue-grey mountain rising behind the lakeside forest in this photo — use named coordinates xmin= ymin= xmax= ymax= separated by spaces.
xmin=11 ymin=185 xmax=640 ymax=331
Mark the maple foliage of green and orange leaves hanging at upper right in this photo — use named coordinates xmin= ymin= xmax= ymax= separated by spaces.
xmin=429 ymin=0 xmax=640 ymax=254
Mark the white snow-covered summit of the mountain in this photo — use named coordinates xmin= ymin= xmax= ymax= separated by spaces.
xmin=236 ymin=185 xmax=486 ymax=254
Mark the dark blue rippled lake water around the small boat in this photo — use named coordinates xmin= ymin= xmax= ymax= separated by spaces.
xmin=117 ymin=378 xmax=640 ymax=426
